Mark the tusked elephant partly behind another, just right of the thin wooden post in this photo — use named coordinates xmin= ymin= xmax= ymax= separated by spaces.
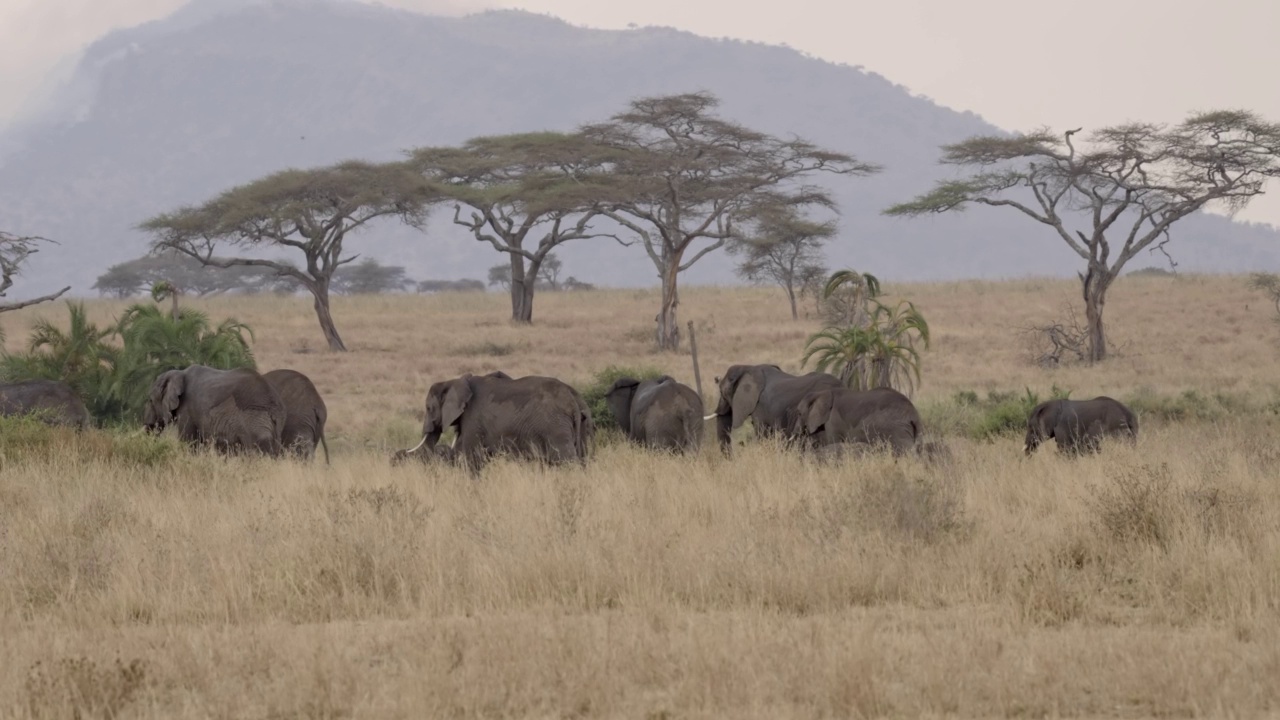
xmin=716 ymin=365 xmax=844 ymax=455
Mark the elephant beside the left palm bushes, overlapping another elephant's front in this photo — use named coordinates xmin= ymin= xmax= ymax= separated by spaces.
xmin=142 ymin=365 xmax=285 ymax=457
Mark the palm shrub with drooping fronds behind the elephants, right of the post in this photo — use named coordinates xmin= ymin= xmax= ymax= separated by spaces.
xmin=800 ymin=270 xmax=929 ymax=395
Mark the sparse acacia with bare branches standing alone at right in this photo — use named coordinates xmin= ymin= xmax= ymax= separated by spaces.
xmin=884 ymin=110 xmax=1280 ymax=361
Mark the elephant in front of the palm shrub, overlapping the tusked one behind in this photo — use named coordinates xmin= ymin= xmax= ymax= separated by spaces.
xmin=794 ymin=387 xmax=922 ymax=456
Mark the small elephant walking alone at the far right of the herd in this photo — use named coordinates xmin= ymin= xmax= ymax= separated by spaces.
xmin=1023 ymin=397 xmax=1138 ymax=455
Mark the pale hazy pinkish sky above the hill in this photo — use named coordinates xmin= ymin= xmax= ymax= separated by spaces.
xmin=0 ymin=0 xmax=1280 ymax=224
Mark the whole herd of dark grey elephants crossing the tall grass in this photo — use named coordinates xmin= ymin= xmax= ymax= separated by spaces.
xmin=0 ymin=365 xmax=1138 ymax=474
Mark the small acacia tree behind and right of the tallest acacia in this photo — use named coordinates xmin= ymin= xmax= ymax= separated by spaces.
xmin=728 ymin=199 xmax=836 ymax=320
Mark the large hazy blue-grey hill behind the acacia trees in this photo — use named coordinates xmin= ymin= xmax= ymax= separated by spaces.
xmin=0 ymin=0 xmax=1280 ymax=295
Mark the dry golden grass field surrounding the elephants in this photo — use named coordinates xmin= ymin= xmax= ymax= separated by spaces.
xmin=0 ymin=271 xmax=1280 ymax=719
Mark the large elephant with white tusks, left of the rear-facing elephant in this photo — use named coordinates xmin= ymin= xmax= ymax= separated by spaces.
xmin=393 ymin=373 xmax=595 ymax=474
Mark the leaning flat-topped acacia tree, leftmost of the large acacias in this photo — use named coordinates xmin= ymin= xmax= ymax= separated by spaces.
xmin=141 ymin=160 xmax=435 ymax=351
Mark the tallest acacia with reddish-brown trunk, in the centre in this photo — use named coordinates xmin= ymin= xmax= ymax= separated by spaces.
xmin=581 ymin=92 xmax=879 ymax=350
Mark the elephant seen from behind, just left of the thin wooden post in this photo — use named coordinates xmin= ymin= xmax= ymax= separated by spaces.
xmin=604 ymin=375 xmax=703 ymax=454
